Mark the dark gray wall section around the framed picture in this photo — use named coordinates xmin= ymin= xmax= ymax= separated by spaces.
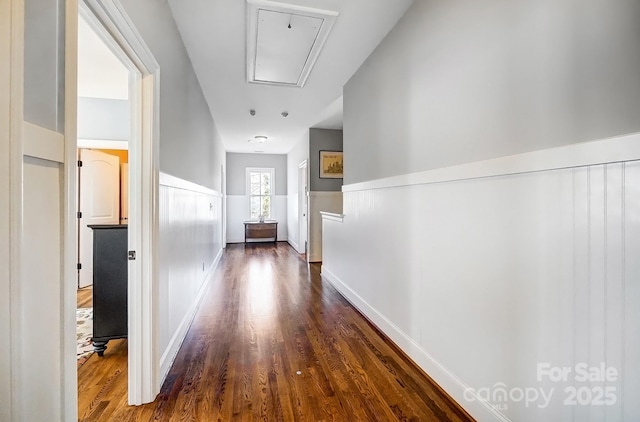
xmin=309 ymin=129 xmax=342 ymax=192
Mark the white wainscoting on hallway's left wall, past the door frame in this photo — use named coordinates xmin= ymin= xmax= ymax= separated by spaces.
xmin=158 ymin=174 xmax=222 ymax=380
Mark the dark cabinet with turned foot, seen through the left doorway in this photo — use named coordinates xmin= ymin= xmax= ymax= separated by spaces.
xmin=89 ymin=224 xmax=129 ymax=356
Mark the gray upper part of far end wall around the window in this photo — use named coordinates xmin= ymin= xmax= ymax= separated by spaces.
xmin=227 ymin=152 xmax=287 ymax=195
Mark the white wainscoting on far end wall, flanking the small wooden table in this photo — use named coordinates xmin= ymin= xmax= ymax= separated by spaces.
xmin=227 ymin=195 xmax=287 ymax=243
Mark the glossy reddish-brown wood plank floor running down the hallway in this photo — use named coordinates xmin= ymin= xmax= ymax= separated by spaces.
xmin=78 ymin=243 xmax=473 ymax=422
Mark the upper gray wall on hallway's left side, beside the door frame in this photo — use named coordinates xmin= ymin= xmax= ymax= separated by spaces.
xmin=122 ymin=0 xmax=225 ymax=191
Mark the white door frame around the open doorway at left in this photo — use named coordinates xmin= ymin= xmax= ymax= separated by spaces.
xmin=65 ymin=0 xmax=160 ymax=405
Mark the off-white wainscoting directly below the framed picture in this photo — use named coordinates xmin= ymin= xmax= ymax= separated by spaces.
xmin=307 ymin=191 xmax=342 ymax=262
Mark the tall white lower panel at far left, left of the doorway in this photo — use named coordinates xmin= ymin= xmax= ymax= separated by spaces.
xmin=20 ymin=157 xmax=63 ymax=421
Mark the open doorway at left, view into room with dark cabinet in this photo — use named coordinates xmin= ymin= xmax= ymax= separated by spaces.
xmin=76 ymin=4 xmax=132 ymax=406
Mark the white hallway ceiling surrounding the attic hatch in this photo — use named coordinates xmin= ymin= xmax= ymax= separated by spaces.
xmin=169 ymin=0 xmax=413 ymax=154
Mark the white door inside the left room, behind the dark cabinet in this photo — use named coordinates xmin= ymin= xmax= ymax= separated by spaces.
xmin=78 ymin=149 xmax=120 ymax=288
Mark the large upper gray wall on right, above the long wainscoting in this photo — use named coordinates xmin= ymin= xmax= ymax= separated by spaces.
xmin=344 ymin=0 xmax=640 ymax=184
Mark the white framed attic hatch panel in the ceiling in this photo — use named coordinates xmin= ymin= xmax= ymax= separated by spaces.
xmin=247 ymin=0 xmax=338 ymax=87
